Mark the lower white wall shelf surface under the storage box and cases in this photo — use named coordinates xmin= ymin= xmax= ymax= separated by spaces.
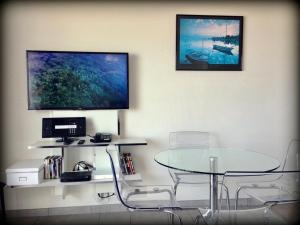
xmin=8 ymin=173 xmax=142 ymax=188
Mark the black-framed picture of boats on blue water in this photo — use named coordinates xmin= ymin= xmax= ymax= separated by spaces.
xmin=176 ymin=15 xmax=243 ymax=71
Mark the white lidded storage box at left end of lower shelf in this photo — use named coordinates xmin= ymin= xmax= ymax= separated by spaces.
xmin=6 ymin=159 xmax=44 ymax=186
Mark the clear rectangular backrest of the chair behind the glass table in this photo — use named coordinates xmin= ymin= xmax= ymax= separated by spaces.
xmin=169 ymin=131 xmax=210 ymax=148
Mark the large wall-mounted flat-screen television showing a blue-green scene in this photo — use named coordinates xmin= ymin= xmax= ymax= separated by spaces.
xmin=27 ymin=50 xmax=129 ymax=110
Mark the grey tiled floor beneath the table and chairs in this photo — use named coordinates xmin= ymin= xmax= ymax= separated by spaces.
xmin=1 ymin=207 xmax=296 ymax=225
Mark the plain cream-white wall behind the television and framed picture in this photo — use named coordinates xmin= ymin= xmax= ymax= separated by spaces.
xmin=1 ymin=1 xmax=298 ymax=209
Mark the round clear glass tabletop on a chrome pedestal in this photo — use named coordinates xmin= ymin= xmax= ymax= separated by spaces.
xmin=154 ymin=148 xmax=280 ymax=175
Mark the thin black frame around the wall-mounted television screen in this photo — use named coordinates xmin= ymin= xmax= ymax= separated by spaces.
xmin=26 ymin=50 xmax=130 ymax=110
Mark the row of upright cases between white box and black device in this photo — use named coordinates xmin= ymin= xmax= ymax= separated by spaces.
xmin=44 ymin=155 xmax=63 ymax=179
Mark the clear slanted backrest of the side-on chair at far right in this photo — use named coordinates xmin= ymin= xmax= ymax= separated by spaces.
xmin=281 ymin=139 xmax=300 ymax=171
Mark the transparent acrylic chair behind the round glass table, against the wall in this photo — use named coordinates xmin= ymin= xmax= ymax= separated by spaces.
xmin=168 ymin=131 xmax=230 ymax=210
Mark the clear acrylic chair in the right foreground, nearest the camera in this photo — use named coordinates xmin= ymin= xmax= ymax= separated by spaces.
xmin=219 ymin=170 xmax=300 ymax=224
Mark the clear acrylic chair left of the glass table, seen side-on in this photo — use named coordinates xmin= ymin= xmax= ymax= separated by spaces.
xmin=106 ymin=146 xmax=186 ymax=225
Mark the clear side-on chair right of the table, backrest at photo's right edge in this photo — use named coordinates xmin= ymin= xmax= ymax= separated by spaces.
xmin=235 ymin=139 xmax=300 ymax=210
